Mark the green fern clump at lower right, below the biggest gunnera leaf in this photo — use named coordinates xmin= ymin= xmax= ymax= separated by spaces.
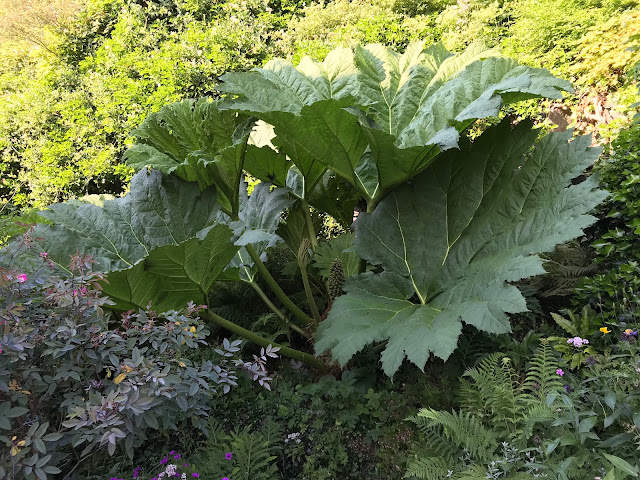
xmin=407 ymin=341 xmax=563 ymax=480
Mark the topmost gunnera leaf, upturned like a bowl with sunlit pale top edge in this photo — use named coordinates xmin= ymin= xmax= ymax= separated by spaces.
xmin=219 ymin=42 xmax=571 ymax=204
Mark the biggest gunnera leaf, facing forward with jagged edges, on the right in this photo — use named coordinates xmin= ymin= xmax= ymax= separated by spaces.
xmin=316 ymin=121 xmax=606 ymax=376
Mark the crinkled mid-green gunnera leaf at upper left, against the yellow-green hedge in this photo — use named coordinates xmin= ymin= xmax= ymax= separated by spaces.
xmin=125 ymin=99 xmax=290 ymax=216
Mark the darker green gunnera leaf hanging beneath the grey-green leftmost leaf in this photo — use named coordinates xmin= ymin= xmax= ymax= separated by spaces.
xmin=103 ymin=225 xmax=239 ymax=312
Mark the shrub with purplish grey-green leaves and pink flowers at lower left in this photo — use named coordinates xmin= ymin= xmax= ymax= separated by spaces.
xmin=0 ymin=246 xmax=258 ymax=479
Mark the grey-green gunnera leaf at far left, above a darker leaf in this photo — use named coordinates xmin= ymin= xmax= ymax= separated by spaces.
xmin=34 ymin=170 xmax=219 ymax=272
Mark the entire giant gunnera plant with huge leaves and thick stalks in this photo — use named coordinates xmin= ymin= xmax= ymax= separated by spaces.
xmin=15 ymin=38 xmax=603 ymax=376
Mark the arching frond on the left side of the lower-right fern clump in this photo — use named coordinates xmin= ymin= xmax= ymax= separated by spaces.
xmin=417 ymin=408 xmax=498 ymax=460
